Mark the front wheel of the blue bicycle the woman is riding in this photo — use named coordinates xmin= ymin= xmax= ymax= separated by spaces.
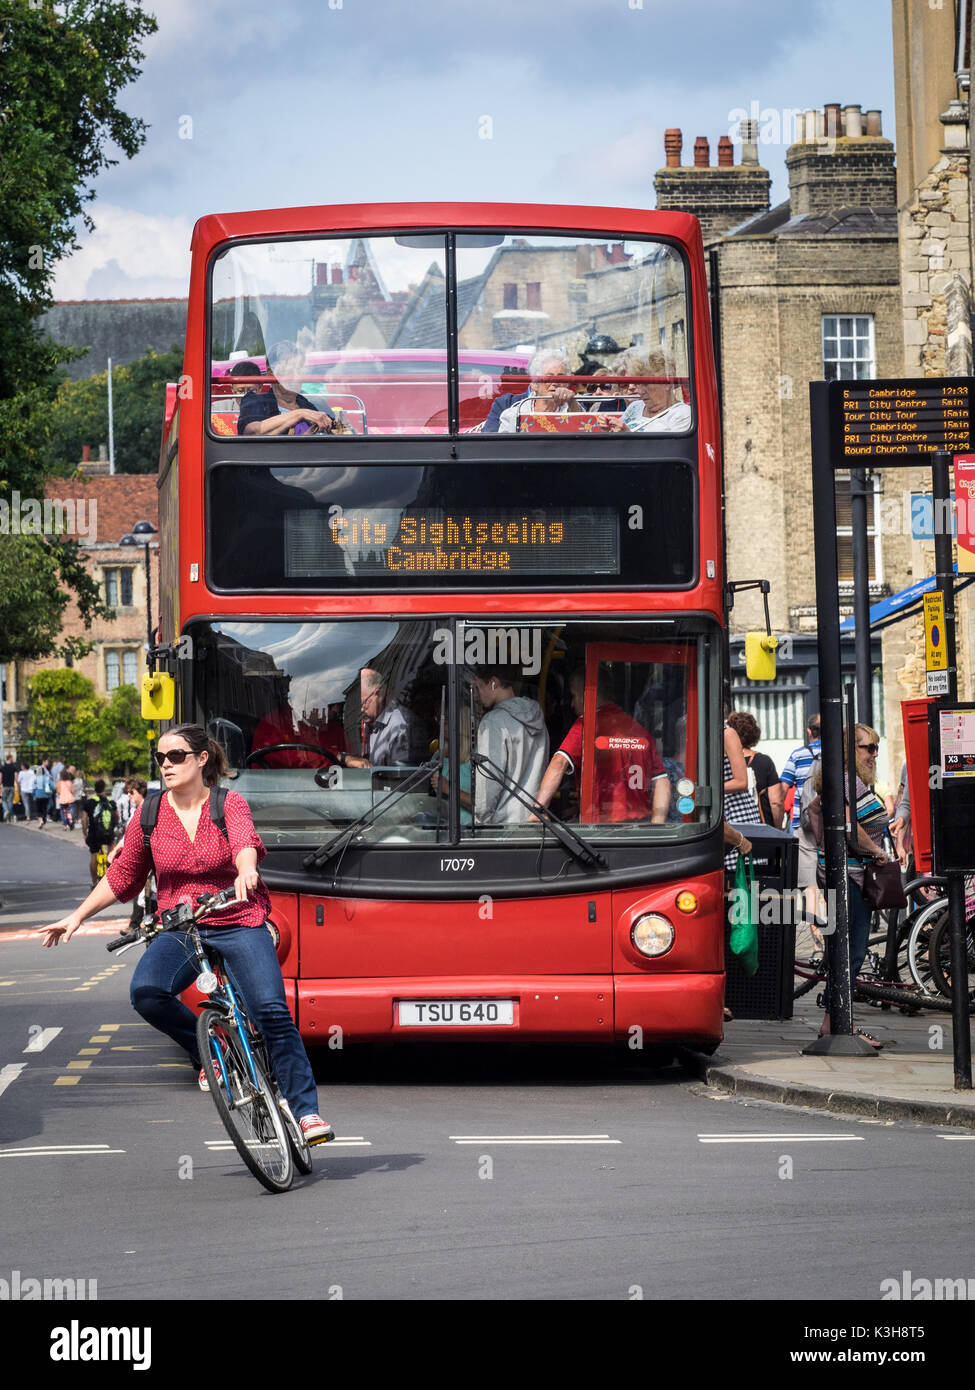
xmin=196 ymin=1009 xmax=295 ymax=1193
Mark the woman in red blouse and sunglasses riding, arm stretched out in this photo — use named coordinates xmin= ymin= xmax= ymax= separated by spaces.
xmin=42 ymin=724 xmax=335 ymax=1144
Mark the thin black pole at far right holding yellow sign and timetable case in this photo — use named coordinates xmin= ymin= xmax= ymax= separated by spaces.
xmin=930 ymin=450 xmax=972 ymax=1091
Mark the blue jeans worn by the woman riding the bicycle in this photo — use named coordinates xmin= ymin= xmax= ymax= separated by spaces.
xmin=129 ymin=927 xmax=319 ymax=1120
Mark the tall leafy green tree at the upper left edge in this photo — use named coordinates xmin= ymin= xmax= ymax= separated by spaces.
xmin=0 ymin=0 xmax=156 ymax=657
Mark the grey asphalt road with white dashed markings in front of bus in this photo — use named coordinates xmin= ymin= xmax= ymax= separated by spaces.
xmin=0 ymin=827 xmax=975 ymax=1315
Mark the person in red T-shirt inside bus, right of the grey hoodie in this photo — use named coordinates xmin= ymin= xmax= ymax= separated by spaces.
xmin=537 ymin=669 xmax=670 ymax=826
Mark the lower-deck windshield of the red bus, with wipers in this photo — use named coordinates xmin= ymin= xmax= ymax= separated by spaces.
xmin=192 ymin=617 xmax=720 ymax=848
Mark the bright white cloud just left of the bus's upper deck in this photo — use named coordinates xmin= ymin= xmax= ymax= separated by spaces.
xmin=54 ymin=203 xmax=192 ymax=300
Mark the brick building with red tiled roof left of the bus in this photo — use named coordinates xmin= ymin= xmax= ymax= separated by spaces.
xmin=3 ymin=463 xmax=159 ymax=752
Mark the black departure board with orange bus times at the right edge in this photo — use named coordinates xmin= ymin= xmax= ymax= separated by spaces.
xmin=832 ymin=378 xmax=972 ymax=461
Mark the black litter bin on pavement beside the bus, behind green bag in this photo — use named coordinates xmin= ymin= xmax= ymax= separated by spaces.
xmin=725 ymin=821 xmax=798 ymax=1019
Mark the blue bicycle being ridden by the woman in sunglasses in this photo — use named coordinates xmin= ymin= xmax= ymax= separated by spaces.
xmin=107 ymin=888 xmax=312 ymax=1193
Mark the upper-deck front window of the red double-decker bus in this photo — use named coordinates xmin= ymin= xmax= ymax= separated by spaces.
xmin=209 ymin=232 xmax=693 ymax=439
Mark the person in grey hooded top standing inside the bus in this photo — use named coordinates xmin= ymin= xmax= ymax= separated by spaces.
xmin=462 ymin=666 xmax=548 ymax=826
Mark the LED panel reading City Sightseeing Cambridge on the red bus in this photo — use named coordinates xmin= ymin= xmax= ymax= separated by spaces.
xmin=284 ymin=507 xmax=620 ymax=580
